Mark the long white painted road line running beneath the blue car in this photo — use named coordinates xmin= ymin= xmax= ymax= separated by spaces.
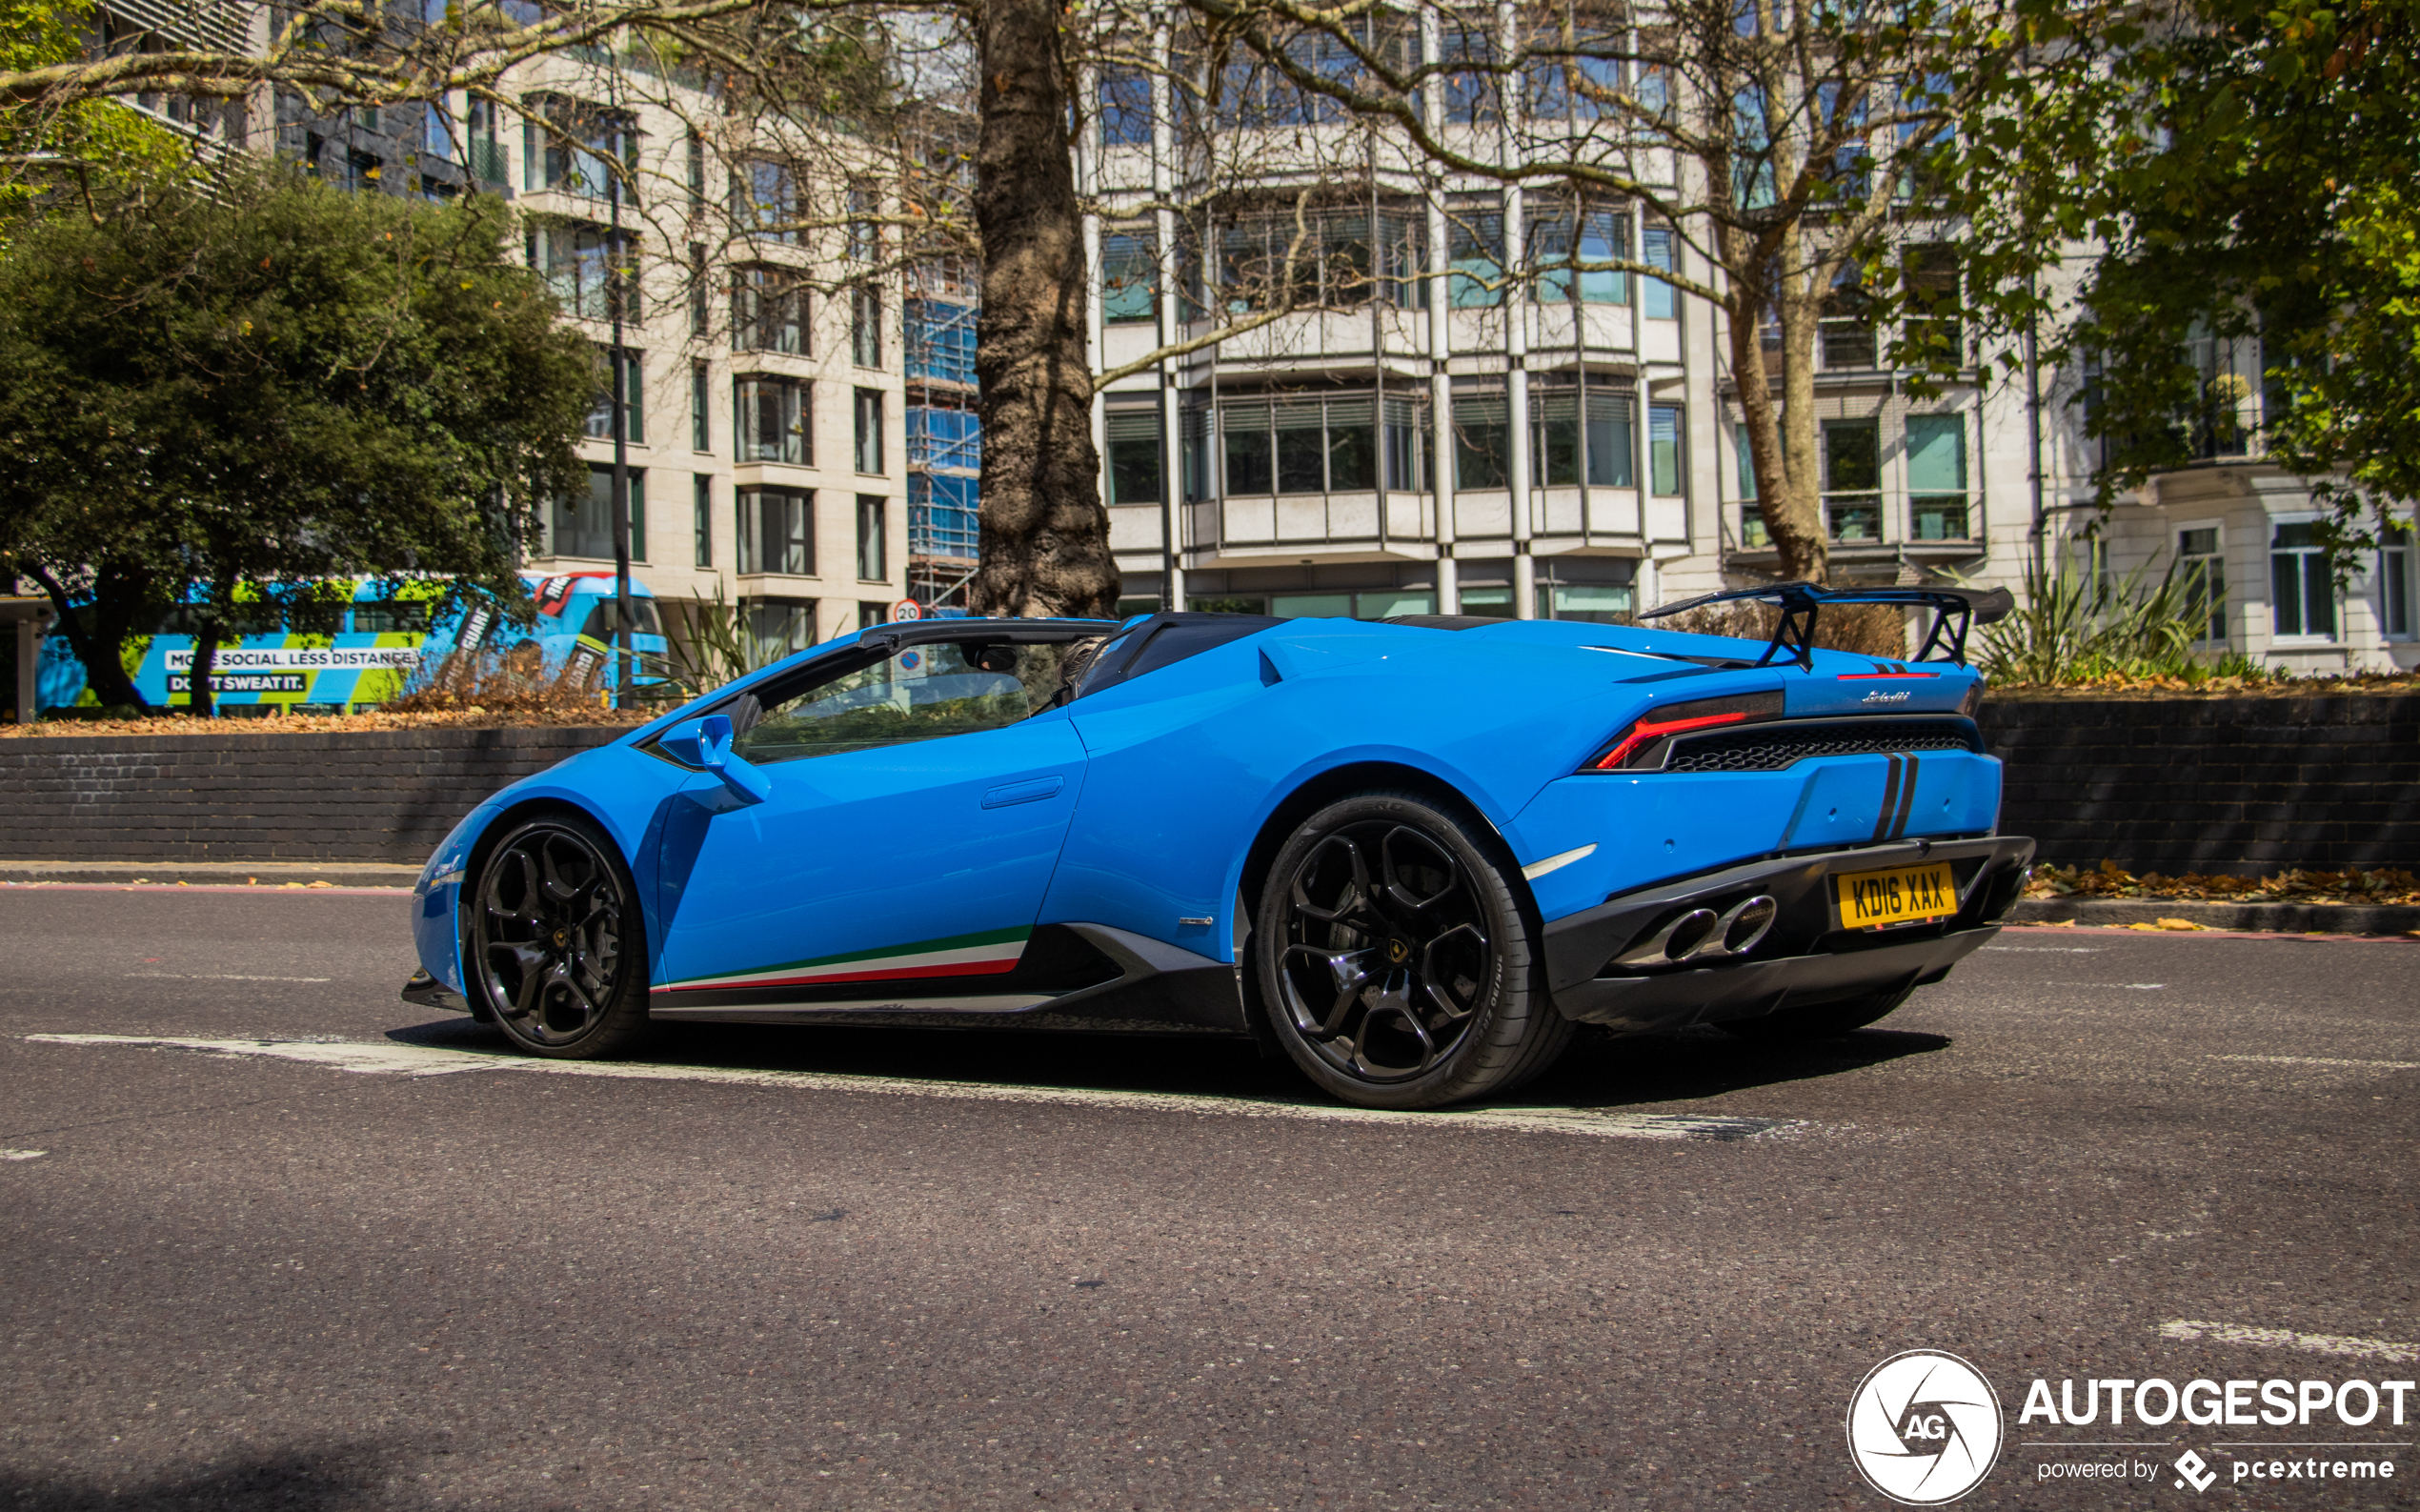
xmin=27 ymin=1036 xmax=1807 ymax=1142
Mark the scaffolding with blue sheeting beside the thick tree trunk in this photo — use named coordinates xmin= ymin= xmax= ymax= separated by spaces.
xmin=900 ymin=259 xmax=982 ymax=612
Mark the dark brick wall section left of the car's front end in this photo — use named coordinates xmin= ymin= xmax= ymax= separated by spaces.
xmin=0 ymin=726 xmax=624 ymax=863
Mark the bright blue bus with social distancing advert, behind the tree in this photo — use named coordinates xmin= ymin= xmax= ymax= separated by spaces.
xmin=39 ymin=571 xmax=671 ymax=714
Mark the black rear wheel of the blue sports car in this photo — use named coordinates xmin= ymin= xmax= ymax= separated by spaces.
xmin=1254 ymin=794 xmax=1570 ymax=1108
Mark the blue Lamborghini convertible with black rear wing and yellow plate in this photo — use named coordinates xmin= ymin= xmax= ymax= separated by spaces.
xmin=404 ymin=583 xmax=2033 ymax=1108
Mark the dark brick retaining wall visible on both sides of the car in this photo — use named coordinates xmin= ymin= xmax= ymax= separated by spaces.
xmin=0 ymin=696 xmax=2420 ymax=876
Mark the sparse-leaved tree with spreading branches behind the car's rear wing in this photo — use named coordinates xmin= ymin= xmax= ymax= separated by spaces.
xmin=1103 ymin=0 xmax=2101 ymax=580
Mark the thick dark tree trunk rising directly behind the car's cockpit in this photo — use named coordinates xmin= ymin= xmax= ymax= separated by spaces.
xmin=973 ymin=0 xmax=1118 ymax=619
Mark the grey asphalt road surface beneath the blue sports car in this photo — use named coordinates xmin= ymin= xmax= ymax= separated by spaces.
xmin=0 ymin=890 xmax=2420 ymax=1509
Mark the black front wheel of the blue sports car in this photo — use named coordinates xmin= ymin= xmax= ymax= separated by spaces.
xmin=465 ymin=816 xmax=646 ymax=1059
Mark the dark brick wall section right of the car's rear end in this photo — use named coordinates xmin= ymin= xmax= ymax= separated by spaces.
xmin=1980 ymin=695 xmax=2420 ymax=876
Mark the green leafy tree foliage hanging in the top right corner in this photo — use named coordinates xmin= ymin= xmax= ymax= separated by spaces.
xmin=2067 ymin=0 xmax=2420 ymax=571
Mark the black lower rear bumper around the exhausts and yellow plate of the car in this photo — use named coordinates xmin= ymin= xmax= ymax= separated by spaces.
xmin=1546 ymin=835 xmax=2033 ymax=1031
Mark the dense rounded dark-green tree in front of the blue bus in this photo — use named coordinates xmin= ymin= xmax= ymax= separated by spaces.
xmin=0 ymin=165 xmax=595 ymax=709
